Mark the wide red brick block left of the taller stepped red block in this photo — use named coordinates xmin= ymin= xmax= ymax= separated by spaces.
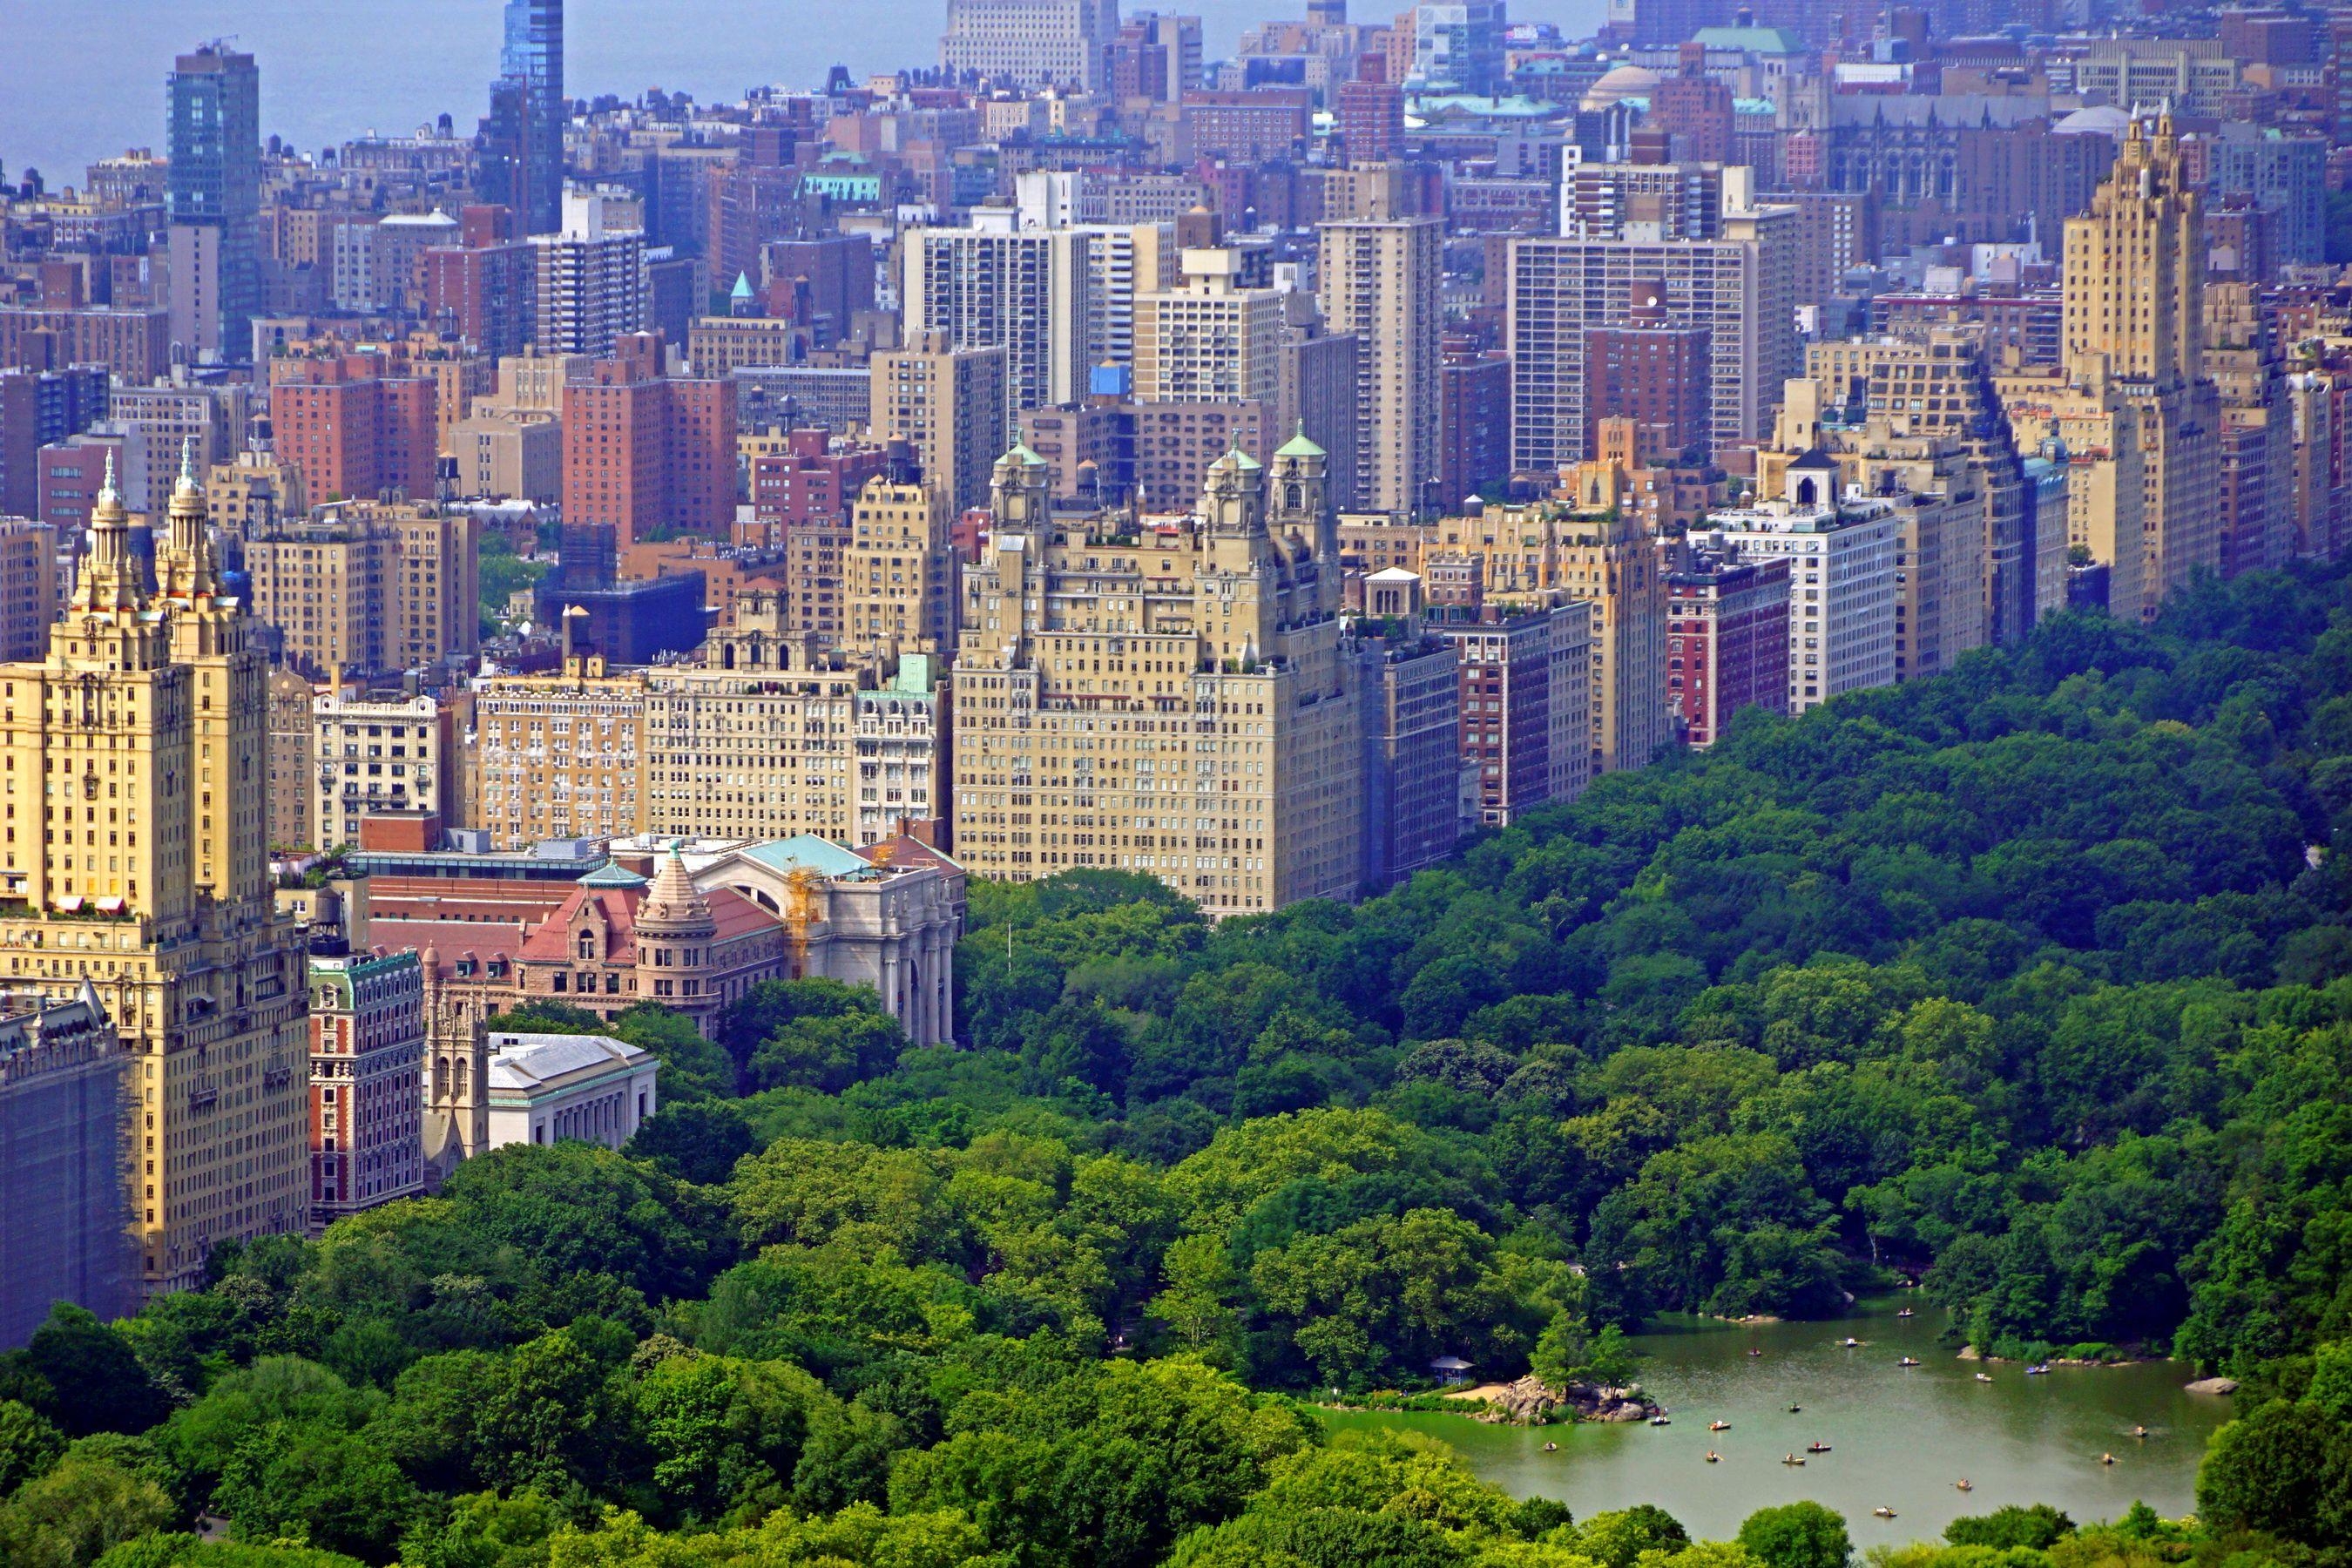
xmin=271 ymin=355 xmax=440 ymax=501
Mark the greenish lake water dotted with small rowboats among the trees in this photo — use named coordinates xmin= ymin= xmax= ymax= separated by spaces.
xmin=1327 ymin=1300 xmax=2230 ymax=1547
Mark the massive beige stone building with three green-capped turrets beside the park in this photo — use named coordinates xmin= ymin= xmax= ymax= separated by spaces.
xmin=953 ymin=440 xmax=1364 ymax=916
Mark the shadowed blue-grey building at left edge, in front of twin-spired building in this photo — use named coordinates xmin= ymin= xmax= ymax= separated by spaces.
xmin=0 ymin=980 xmax=139 ymax=1349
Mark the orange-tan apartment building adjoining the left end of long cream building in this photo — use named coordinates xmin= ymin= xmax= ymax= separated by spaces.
xmin=468 ymin=653 xmax=647 ymax=848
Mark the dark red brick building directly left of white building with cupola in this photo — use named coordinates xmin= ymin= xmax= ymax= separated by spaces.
xmin=1666 ymin=543 xmax=1788 ymax=745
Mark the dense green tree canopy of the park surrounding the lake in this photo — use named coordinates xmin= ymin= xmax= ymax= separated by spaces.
xmin=13 ymin=561 xmax=2352 ymax=1568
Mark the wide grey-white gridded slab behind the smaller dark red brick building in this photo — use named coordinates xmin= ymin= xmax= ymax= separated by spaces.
xmin=1505 ymin=205 xmax=1800 ymax=470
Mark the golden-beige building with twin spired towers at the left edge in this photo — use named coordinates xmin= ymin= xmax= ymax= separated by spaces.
xmin=0 ymin=465 xmax=308 ymax=1291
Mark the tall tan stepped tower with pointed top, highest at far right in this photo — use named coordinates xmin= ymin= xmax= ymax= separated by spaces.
xmin=2065 ymin=113 xmax=2220 ymax=616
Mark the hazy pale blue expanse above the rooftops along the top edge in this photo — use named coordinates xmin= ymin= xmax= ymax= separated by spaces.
xmin=0 ymin=0 xmax=1604 ymax=188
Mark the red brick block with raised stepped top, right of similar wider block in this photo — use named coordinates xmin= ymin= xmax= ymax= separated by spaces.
xmin=562 ymin=332 xmax=736 ymax=545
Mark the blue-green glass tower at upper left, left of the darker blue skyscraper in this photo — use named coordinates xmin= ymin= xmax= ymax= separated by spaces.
xmin=165 ymin=43 xmax=261 ymax=360
